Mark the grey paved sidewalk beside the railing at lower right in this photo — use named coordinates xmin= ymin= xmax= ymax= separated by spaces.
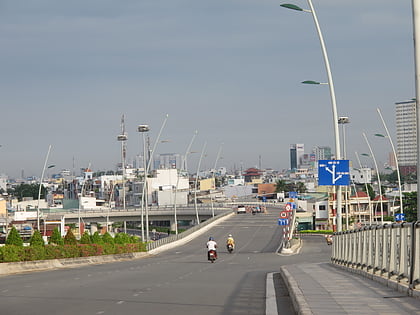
xmin=280 ymin=263 xmax=420 ymax=315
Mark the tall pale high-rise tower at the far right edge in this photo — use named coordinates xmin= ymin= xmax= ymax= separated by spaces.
xmin=395 ymin=100 xmax=417 ymax=174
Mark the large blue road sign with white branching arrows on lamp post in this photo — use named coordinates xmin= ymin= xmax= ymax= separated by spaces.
xmin=318 ymin=160 xmax=350 ymax=186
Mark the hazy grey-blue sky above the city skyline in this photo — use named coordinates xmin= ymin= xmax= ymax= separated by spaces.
xmin=0 ymin=0 xmax=415 ymax=177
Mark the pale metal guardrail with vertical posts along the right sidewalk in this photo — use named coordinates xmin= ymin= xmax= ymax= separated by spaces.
xmin=331 ymin=221 xmax=420 ymax=295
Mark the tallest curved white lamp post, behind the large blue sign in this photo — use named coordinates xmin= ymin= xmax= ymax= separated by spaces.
xmin=280 ymin=0 xmax=342 ymax=232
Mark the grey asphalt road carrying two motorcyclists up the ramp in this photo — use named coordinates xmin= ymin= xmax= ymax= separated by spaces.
xmin=0 ymin=210 xmax=330 ymax=315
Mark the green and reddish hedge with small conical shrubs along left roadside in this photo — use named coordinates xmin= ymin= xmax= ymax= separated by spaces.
xmin=0 ymin=227 xmax=146 ymax=263
